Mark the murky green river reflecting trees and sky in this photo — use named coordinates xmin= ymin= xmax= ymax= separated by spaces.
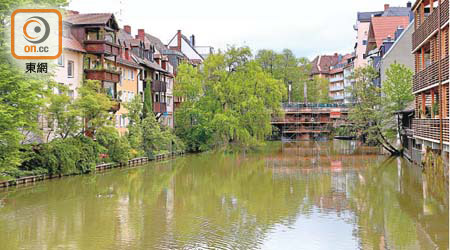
xmin=0 ymin=141 xmax=449 ymax=250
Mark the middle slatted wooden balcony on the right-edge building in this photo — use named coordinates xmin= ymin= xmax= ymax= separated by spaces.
xmin=413 ymin=56 xmax=449 ymax=92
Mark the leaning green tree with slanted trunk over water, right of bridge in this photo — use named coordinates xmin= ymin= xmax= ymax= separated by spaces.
xmin=349 ymin=66 xmax=401 ymax=155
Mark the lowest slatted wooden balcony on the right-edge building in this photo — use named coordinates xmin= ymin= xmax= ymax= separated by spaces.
xmin=413 ymin=118 xmax=449 ymax=143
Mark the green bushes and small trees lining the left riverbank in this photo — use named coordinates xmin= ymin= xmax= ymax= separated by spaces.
xmin=0 ymin=81 xmax=184 ymax=182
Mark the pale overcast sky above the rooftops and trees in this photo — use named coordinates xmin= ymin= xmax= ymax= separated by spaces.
xmin=69 ymin=0 xmax=407 ymax=59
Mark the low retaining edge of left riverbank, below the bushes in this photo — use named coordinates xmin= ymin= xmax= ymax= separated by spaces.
xmin=0 ymin=151 xmax=185 ymax=189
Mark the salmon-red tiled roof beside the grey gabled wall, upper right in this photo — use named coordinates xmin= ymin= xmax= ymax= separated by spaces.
xmin=369 ymin=16 xmax=409 ymax=48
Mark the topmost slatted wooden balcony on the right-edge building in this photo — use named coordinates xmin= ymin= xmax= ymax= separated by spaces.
xmin=412 ymin=0 xmax=449 ymax=50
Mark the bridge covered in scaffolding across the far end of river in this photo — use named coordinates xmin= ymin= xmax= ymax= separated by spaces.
xmin=271 ymin=103 xmax=349 ymax=141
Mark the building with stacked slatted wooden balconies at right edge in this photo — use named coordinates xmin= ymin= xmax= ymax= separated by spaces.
xmin=412 ymin=0 xmax=449 ymax=165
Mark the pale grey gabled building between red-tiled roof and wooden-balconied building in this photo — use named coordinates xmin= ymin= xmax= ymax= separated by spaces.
xmin=379 ymin=21 xmax=414 ymax=82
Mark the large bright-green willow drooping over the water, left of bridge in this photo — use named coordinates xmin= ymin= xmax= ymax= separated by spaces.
xmin=175 ymin=47 xmax=286 ymax=151
